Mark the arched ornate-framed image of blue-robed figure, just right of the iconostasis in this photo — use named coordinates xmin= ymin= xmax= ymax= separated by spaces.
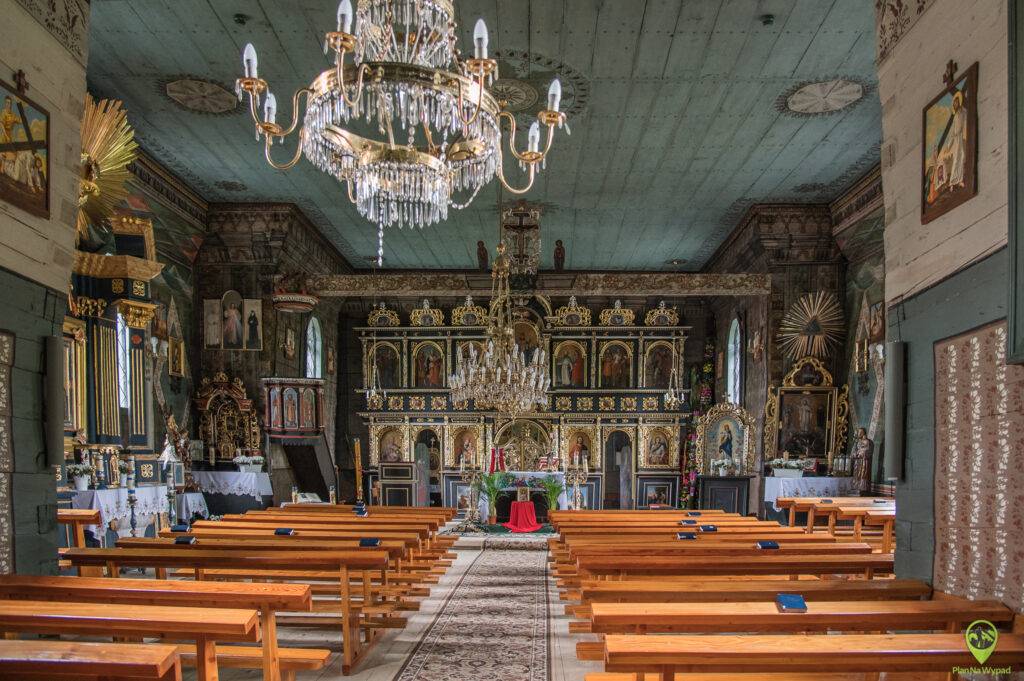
xmin=696 ymin=402 xmax=757 ymax=475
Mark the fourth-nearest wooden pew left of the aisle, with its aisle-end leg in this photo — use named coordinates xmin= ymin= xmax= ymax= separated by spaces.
xmin=68 ymin=547 xmax=388 ymax=674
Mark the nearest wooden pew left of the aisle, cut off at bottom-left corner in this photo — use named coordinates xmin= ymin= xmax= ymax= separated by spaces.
xmin=0 ymin=640 xmax=181 ymax=681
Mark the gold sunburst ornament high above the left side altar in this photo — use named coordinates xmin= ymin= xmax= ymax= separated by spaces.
xmin=77 ymin=94 xmax=138 ymax=239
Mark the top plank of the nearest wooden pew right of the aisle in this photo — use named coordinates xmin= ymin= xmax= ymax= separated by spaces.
xmin=604 ymin=634 xmax=1024 ymax=681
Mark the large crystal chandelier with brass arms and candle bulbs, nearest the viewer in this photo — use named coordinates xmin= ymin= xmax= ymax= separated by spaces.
xmin=236 ymin=0 xmax=568 ymax=264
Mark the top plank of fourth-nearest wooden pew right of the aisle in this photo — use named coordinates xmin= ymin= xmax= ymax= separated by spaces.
xmin=577 ymin=553 xmax=893 ymax=579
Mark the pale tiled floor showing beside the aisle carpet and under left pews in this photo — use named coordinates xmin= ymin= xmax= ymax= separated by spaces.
xmin=197 ymin=542 xmax=600 ymax=681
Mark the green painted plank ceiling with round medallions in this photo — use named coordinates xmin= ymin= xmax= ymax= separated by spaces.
xmin=88 ymin=0 xmax=881 ymax=269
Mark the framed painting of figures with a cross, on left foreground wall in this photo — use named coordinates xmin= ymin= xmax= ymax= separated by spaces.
xmin=0 ymin=80 xmax=50 ymax=218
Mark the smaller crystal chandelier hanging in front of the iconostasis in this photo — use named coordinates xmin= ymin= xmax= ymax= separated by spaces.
xmin=449 ymin=244 xmax=551 ymax=418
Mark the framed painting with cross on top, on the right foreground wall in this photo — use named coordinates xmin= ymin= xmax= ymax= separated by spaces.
xmin=921 ymin=61 xmax=978 ymax=224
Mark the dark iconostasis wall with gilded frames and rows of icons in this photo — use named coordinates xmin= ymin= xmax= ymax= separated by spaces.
xmin=356 ymin=295 xmax=689 ymax=508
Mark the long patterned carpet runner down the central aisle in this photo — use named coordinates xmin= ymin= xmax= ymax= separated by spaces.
xmin=395 ymin=549 xmax=551 ymax=681
